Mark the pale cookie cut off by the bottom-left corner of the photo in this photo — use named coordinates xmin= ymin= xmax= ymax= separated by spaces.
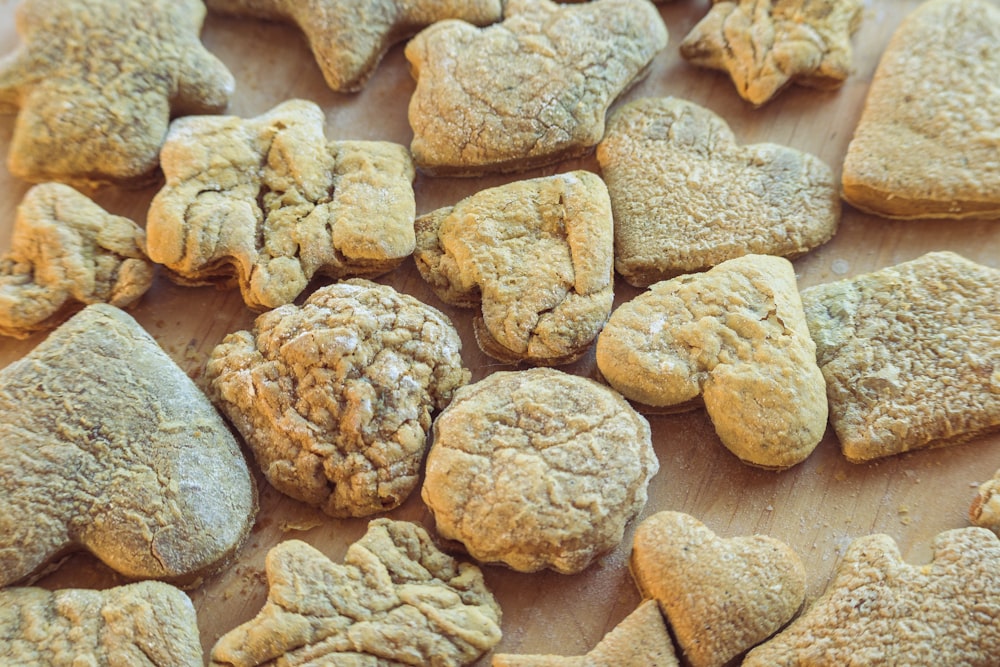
xmin=0 ymin=581 xmax=205 ymax=667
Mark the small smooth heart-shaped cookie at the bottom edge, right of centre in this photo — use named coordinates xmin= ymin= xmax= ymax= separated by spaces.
xmin=629 ymin=512 xmax=806 ymax=667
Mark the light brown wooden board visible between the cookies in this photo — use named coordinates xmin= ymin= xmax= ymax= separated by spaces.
xmin=0 ymin=0 xmax=1000 ymax=665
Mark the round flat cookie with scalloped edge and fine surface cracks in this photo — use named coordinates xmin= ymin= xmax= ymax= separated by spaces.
xmin=421 ymin=368 xmax=659 ymax=574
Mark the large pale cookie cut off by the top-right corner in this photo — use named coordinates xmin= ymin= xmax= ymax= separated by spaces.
xmin=841 ymin=0 xmax=1000 ymax=219
